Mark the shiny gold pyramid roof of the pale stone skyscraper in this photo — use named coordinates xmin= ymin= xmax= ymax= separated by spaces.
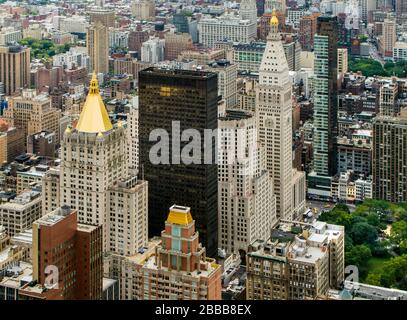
xmin=76 ymin=73 xmax=113 ymax=133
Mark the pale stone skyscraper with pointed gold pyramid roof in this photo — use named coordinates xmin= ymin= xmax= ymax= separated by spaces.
xmin=60 ymin=74 xmax=148 ymax=255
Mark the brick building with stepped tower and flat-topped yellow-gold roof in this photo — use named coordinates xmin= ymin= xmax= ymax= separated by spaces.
xmin=122 ymin=205 xmax=222 ymax=300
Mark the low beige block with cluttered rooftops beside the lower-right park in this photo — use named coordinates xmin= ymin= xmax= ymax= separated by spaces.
xmin=246 ymin=221 xmax=344 ymax=300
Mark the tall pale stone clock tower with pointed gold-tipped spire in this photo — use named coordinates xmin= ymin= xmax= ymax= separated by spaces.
xmin=256 ymin=11 xmax=294 ymax=219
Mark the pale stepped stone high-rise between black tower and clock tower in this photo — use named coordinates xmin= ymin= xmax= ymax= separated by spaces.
xmin=218 ymin=110 xmax=277 ymax=254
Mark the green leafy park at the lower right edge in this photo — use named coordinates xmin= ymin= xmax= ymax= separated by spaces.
xmin=319 ymin=199 xmax=407 ymax=290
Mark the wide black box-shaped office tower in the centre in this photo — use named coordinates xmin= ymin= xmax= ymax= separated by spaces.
xmin=139 ymin=68 xmax=218 ymax=256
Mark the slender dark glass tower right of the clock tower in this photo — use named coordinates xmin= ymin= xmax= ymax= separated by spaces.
xmin=308 ymin=16 xmax=338 ymax=197
